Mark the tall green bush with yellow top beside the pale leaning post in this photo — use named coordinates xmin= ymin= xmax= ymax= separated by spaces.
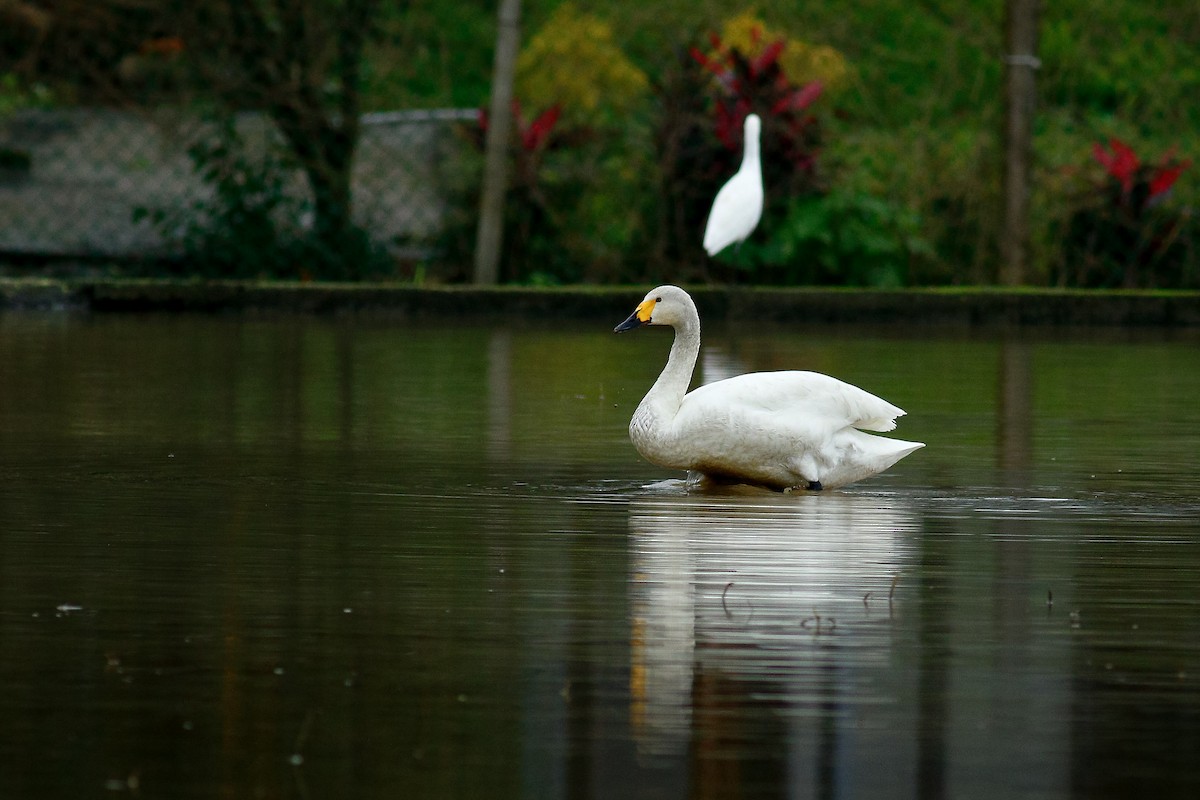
xmin=509 ymin=2 xmax=653 ymax=283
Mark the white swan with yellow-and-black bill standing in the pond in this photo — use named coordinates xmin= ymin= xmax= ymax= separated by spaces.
xmin=614 ymin=285 xmax=925 ymax=489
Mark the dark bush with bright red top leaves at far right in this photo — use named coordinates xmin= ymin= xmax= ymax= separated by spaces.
xmin=1058 ymin=138 xmax=1198 ymax=288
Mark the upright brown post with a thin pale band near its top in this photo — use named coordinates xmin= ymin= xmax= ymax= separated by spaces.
xmin=1000 ymin=0 xmax=1042 ymax=285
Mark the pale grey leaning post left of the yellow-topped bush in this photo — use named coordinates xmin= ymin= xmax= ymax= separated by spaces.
xmin=475 ymin=0 xmax=521 ymax=284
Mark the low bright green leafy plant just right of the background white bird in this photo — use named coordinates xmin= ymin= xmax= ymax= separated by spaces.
xmin=733 ymin=190 xmax=934 ymax=288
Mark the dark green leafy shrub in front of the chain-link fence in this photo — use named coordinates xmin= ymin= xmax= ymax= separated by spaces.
xmin=134 ymin=120 xmax=380 ymax=278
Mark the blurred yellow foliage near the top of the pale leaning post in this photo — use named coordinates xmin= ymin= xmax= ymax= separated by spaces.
xmin=516 ymin=2 xmax=649 ymax=122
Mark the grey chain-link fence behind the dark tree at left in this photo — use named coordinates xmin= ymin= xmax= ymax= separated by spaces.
xmin=0 ymin=109 xmax=476 ymax=260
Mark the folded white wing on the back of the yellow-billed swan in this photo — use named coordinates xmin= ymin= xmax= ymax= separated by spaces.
xmin=680 ymin=371 xmax=904 ymax=433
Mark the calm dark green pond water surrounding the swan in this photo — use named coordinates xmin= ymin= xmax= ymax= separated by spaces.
xmin=0 ymin=314 xmax=1200 ymax=799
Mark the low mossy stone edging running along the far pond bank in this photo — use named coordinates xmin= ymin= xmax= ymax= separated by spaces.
xmin=0 ymin=278 xmax=1200 ymax=327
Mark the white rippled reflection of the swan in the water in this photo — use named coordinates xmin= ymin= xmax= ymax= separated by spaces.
xmin=629 ymin=489 xmax=918 ymax=754
